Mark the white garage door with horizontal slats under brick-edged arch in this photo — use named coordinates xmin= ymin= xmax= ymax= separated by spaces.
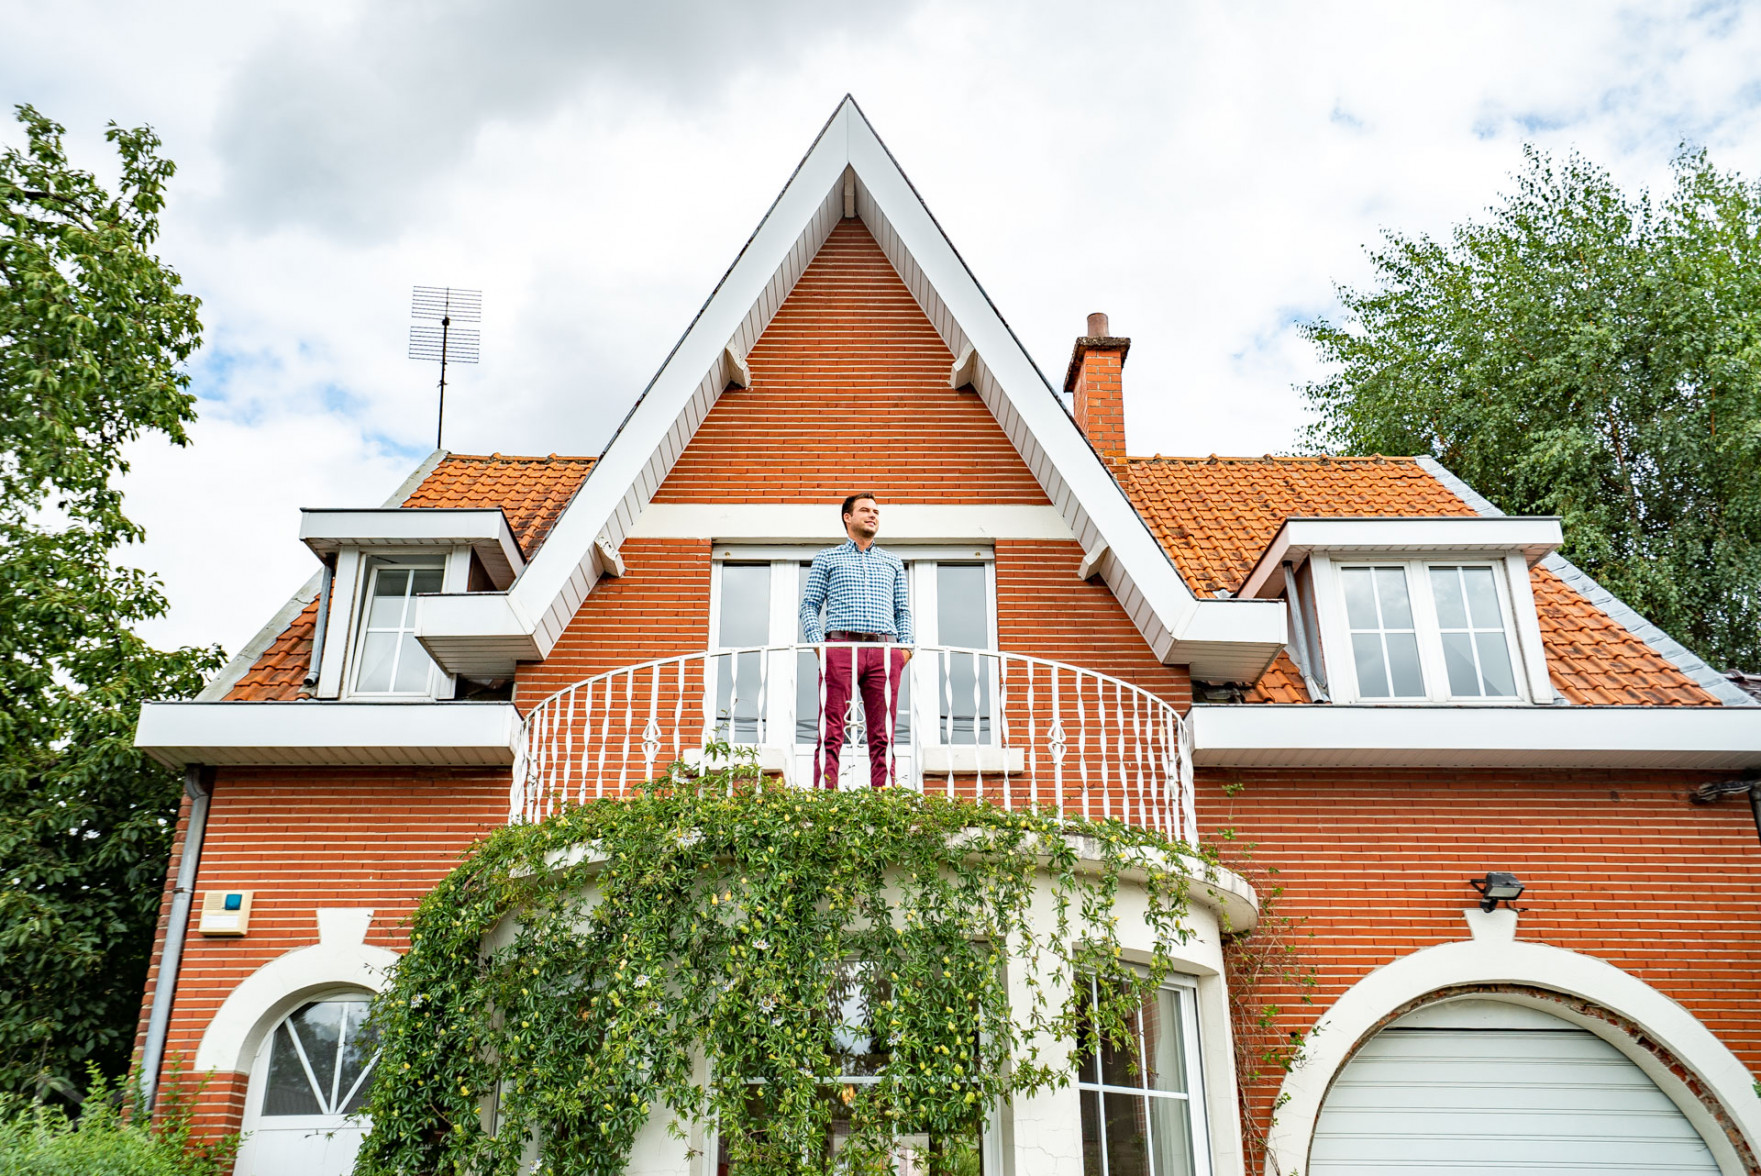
xmin=1308 ymin=1000 xmax=1719 ymax=1176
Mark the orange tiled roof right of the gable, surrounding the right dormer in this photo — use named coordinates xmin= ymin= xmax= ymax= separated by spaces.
xmin=1122 ymin=456 xmax=1717 ymax=706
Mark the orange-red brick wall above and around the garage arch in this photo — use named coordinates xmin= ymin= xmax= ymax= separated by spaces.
xmin=1197 ymin=771 xmax=1761 ymax=1154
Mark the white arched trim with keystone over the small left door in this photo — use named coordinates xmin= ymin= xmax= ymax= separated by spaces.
xmin=195 ymin=910 xmax=398 ymax=1074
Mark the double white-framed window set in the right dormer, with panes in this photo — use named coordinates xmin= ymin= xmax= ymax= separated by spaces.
xmin=1315 ymin=556 xmax=1527 ymax=702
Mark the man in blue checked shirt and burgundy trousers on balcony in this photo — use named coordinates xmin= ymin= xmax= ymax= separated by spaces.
xmin=801 ymin=491 xmax=914 ymax=789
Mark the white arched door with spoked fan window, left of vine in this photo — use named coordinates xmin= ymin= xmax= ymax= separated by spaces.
xmin=234 ymin=991 xmax=379 ymax=1176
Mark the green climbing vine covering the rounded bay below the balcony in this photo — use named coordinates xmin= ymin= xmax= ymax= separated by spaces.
xmin=356 ymin=764 xmax=1197 ymax=1176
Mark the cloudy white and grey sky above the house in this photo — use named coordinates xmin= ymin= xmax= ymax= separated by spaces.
xmin=0 ymin=0 xmax=1761 ymax=651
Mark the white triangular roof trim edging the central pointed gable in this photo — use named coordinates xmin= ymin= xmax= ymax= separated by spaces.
xmin=417 ymin=97 xmax=1284 ymax=681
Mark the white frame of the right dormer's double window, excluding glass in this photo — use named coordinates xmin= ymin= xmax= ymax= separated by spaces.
xmin=1308 ymin=551 xmax=1553 ymax=706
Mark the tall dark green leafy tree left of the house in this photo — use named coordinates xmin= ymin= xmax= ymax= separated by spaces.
xmin=0 ymin=106 xmax=218 ymax=1095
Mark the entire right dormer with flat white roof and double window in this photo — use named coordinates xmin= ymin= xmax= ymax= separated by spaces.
xmin=1242 ymin=516 xmax=1560 ymax=704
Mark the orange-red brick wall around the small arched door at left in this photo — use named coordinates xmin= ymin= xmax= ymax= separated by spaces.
xmin=141 ymin=768 xmax=507 ymax=1132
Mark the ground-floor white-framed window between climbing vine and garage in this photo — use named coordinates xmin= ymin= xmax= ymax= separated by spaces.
xmin=1076 ymin=979 xmax=1210 ymax=1176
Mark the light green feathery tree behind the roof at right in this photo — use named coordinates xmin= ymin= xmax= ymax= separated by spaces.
xmin=1305 ymin=148 xmax=1761 ymax=669
